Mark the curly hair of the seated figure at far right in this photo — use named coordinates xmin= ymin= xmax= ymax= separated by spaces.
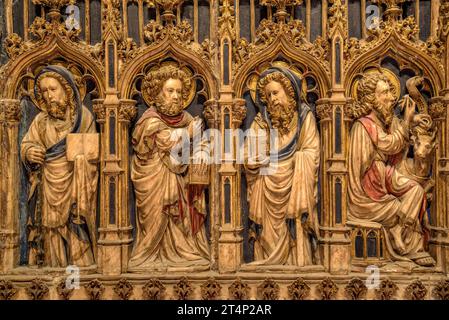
xmin=351 ymin=72 xmax=394 ymax=119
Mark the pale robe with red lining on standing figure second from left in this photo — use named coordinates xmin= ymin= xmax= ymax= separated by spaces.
xmin=129 ymin=108 xmax=209 ymax=270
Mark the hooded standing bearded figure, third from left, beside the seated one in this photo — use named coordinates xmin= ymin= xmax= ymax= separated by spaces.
xmin=245 ymin=67 xmax=321 ymax=266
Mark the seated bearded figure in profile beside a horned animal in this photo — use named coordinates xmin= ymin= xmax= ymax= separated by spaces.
xmin=348 ymin=72 xmax=435 ymax=266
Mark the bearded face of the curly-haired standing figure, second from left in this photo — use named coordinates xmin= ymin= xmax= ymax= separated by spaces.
xmin=156 ymin=79 xmax=183 ymax=116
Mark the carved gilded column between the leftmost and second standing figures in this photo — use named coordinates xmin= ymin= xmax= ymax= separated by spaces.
xmin=94 ymin=97 xmax=136 ymax=275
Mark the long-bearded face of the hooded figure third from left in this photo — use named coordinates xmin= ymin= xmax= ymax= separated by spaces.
xmin=265 ymin=81 xmax=295 ymax=134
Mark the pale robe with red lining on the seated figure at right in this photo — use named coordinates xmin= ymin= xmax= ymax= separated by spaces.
xmin=348 ymin=113 xmax=429 ymax=261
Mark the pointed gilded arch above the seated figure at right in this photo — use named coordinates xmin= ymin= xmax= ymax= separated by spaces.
xmin=344 ymin=32 xmax=444 ymax=96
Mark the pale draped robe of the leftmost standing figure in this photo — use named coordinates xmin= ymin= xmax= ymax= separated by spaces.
xmin=21 ymin=106 xmax=98 ymax=267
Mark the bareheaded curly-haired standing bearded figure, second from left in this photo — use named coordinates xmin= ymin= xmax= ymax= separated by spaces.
xmin=129 ymin=65 xmax=209 ymax=271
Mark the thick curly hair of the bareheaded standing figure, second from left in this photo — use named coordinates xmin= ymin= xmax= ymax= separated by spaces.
xmin=142 ymin=65 xmax=192 ymax=101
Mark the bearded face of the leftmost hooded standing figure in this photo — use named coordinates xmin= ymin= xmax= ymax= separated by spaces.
xmin=40 ymin=77 xmax=68 ymax=120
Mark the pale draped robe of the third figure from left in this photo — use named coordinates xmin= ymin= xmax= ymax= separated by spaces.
xmin=245 ymin=112 xmax=320 ymax=266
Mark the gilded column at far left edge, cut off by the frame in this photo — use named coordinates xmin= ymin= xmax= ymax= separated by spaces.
xmin=0 ymin=99 xmax=21 ymax=273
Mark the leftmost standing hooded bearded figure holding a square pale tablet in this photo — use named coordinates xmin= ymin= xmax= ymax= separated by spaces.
xmin=20 ymin=66 xmax=99 ymax=267
